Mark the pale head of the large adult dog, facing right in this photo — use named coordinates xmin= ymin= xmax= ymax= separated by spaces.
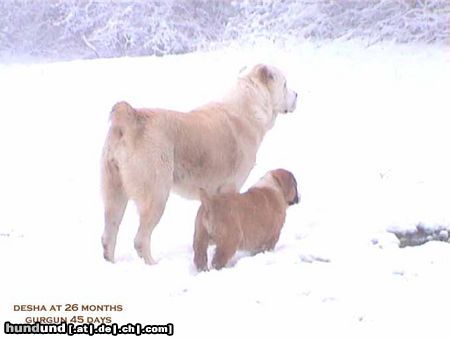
xmin=249 ymin=64 xmax=297 ymax=114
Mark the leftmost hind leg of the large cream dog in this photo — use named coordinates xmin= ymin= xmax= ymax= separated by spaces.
xmin=102 ymin=162 xmax=128 ymax=262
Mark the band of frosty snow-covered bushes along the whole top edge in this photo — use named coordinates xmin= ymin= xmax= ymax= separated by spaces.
xmin=0 ymin=0 xmax=450 ymax=59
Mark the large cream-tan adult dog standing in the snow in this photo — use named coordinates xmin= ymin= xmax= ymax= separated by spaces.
xmin=101 ymin=65 xmax=297 ymax=264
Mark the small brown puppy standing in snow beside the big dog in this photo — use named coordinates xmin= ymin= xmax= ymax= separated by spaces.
xmin=193 ymin=169 xmax=299 ymax=270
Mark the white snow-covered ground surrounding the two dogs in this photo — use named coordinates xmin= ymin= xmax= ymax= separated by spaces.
xmin=0 ymin=42 xmax=450 ymax=337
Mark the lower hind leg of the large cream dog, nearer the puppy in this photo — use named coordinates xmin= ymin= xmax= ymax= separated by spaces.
xmin=134 ymin=186 xmax=170 ymax=265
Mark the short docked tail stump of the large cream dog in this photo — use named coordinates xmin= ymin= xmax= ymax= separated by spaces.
xmin=110 ymin=101 xmax=143 ymax=134
